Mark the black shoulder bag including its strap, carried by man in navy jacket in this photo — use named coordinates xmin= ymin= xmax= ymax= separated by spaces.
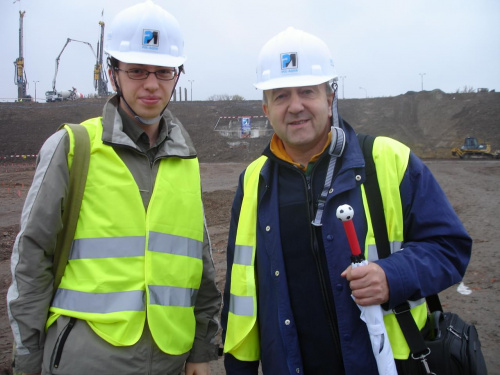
xmin=358 ymin=134 xmax=487 ymax=375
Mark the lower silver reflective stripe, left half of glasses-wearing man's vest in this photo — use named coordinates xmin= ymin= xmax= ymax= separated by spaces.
xmin=52 ymin=289 xmax=144 ymax=314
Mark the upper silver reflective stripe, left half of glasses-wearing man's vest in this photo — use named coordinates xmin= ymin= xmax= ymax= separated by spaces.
xmin=69 ymin=236 xmax=146 ymax=259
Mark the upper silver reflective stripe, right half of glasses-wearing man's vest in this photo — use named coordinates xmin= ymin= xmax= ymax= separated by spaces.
xmin=148 ymin=232 xmax=203 ymax=259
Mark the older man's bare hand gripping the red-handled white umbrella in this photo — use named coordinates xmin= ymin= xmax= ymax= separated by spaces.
xmin=340 ymin=263 xmax=389 ymax=306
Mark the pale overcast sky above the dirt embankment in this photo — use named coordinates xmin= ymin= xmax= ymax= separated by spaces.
xmin=0 ymin=0 xmax=500 ymax=101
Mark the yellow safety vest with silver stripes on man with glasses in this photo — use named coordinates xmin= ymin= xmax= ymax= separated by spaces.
xmin=47 ymin=118 xmax=204 ymax=355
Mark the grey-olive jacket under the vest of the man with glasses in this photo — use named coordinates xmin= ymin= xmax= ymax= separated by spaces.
xmin=7 ymin=96 xmax=221 ymax=374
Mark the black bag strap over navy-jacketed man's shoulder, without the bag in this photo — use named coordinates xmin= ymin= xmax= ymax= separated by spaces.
xmin=358 ymin=134 xmax=442 ymax=359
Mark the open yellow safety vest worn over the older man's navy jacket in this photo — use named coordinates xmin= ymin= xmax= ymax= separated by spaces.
xmin=224 ymin=137 xmax=427 ymax=361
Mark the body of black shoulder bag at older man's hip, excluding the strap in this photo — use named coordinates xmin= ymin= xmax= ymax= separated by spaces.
xmin=425 ymin=311 xmax=487 ymax=375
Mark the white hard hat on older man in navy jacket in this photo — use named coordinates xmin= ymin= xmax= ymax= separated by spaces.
xmin=254 ymin=27 xmax=337 ymax=90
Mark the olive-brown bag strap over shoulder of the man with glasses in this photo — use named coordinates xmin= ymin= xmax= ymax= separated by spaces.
xmin=52 ymin=124 xmax=90 ymax=294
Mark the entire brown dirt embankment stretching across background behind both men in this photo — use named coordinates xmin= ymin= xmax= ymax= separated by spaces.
xmin=0 ymin=90 xmax=500 ymax=162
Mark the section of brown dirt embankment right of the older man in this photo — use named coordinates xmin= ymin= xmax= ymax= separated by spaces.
xmin=339 ymin=90 xmax=500 ymax=158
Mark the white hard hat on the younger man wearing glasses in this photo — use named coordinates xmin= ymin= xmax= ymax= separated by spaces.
xmin=105 ymin=0 xmax=186 ymax=67
